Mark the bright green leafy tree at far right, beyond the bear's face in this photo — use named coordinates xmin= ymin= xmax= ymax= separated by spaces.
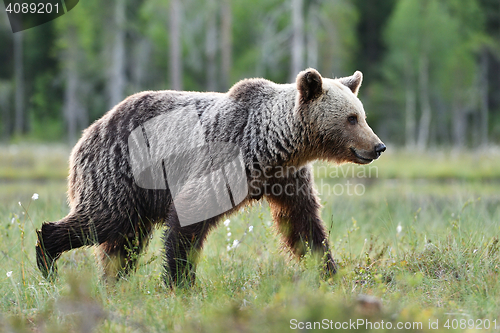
xmin=383 ymin=0 xmax=491 ymax=145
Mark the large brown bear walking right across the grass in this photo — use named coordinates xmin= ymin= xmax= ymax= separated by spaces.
xmin=36 ymin=69 xmax=386 ymax=285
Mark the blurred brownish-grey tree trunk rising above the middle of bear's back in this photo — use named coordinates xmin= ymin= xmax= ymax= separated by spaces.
xmin=169 ymin=0 xmax=182 ymax=90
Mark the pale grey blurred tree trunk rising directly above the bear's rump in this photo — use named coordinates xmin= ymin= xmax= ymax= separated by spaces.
xmin=108 ymin=0 xmax=126 ymax=109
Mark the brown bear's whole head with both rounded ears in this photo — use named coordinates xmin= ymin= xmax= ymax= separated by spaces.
xmin=296 ymin=68 xmax=386 ymax=164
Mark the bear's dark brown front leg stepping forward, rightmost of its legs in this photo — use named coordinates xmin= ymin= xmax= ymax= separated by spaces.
xmin=266 ymin=167 xmax=336 ymax=275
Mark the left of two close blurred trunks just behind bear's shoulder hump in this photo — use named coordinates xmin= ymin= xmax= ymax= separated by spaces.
xmin=205 ymin=0 xmax=217 ymax=91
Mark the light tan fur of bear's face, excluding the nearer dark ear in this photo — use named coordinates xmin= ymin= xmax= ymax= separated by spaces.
xmin=298 ymin=72 xmax=385 ymax=164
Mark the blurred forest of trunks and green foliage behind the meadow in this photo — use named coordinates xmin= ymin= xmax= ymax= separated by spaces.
xmin=0 ymin=0 xmax=500 ymax=150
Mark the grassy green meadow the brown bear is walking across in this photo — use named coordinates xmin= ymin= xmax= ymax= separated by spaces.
xmin=0 ymin=146 xmax=500 ymax=333
